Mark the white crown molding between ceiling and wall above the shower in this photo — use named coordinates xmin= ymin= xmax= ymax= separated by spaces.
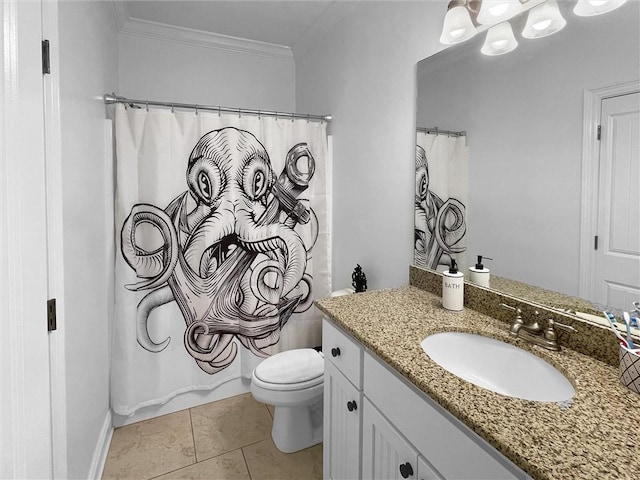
xmin=111 ymin=0 xmax=293 ymax=61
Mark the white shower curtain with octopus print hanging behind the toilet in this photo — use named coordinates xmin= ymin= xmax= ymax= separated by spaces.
xmin=111 ymin=105 xmax=331 ymax=415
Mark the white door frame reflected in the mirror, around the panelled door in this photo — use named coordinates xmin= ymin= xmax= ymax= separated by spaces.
xmin=578 ymin=80 xmax=640 ymax=300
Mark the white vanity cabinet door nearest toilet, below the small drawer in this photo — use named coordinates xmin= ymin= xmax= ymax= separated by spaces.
xmin=323 ymin=362 xmax=362 ymax=480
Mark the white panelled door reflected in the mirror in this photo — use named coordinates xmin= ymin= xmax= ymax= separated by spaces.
xmin=594 ymin=93 xmax=640 ymax=311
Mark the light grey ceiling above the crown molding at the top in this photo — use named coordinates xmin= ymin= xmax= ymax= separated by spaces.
xmin=124 ymin=0 xmax=336 ymax=48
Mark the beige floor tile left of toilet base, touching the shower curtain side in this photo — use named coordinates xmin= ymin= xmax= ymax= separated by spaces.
xmin=191 ymin=393 xmax=272 ymax=462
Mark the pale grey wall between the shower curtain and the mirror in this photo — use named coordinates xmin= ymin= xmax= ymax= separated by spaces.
xmin=294 ymin=1 xmax=447 ymax=289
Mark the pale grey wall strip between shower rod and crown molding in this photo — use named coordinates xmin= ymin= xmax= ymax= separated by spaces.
xmin=116 ymin=33 xmax=295 ymax=112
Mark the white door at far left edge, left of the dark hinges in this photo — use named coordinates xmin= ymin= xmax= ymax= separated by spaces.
xmin=0 ymin=0 xmax=52 ymax=478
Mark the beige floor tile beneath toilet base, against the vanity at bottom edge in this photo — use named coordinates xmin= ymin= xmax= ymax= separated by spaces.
xmin=242 ymin=438 xmax=322 ymax=480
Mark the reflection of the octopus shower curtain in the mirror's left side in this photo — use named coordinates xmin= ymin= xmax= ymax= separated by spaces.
xmin=414 ymin=131 xmax=469 ymax=271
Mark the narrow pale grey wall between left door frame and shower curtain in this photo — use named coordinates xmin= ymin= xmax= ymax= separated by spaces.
xmin=53 ymin=1 xmax=118 ymax=478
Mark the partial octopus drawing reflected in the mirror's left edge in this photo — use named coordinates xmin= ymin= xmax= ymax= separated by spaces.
xmin=414 ymin=145 xmax=467 ymax=270
